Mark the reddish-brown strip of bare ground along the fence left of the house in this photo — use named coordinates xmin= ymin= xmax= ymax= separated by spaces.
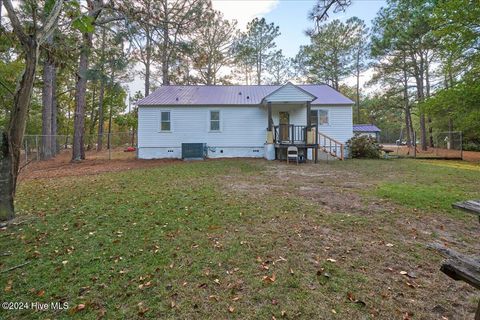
xmin=19 ymin=151 xmax=180 ymax=181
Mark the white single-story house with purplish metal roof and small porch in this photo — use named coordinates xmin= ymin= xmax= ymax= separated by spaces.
xmin=137 ymin=82 xmax=353 ymax=160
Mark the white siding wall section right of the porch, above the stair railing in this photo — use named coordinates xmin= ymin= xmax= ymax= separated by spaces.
xmin=311 ymin=105 xmax=353 ymax=143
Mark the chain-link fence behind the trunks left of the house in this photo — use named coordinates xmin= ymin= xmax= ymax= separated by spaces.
xmin=21 ymin=132 xmax=136 ymax=166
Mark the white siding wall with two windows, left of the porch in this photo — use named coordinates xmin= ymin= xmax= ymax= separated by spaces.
xmin=138 ymin=106 xmax=267 ymax=158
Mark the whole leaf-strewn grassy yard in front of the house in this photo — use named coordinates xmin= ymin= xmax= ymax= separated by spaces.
xmin=0 ymin=160 xmax=480 ymax=319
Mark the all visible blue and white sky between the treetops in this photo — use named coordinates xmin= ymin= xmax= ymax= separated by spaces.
xmin=127 ymin=0 xmax=386 ymax=95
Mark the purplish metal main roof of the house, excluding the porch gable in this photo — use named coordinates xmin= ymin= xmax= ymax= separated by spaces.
xmin=137 ymin=84 xmax=353 ymax=106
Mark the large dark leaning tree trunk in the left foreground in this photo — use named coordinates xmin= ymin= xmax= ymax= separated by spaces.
xmin=0 ymin=43 xmax=38 ymax=221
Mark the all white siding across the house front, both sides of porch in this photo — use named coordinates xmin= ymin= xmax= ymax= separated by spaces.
xmin=138 ymin=104 xmax=353 ymax=159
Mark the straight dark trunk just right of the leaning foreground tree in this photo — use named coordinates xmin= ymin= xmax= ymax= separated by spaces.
xmin=40 ymin=37 xmax=54 ymax=160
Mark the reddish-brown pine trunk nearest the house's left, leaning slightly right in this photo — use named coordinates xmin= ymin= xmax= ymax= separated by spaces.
xmin=72 ymin=33 xmax=92 ymax=161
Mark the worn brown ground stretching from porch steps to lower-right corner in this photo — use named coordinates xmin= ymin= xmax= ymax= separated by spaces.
xmin=222 ymin=162 xmax=480 ymax=319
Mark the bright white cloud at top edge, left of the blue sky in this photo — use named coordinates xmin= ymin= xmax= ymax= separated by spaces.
xmin=212 ymin=0 xmax=280 ymax=30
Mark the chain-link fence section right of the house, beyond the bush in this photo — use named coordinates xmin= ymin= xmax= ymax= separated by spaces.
xmin=384 ymin=131 xmax=463 ymax=159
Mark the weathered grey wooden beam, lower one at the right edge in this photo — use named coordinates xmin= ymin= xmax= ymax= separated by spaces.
xmin=429 ymin=243 xmax=480 ymax=289
